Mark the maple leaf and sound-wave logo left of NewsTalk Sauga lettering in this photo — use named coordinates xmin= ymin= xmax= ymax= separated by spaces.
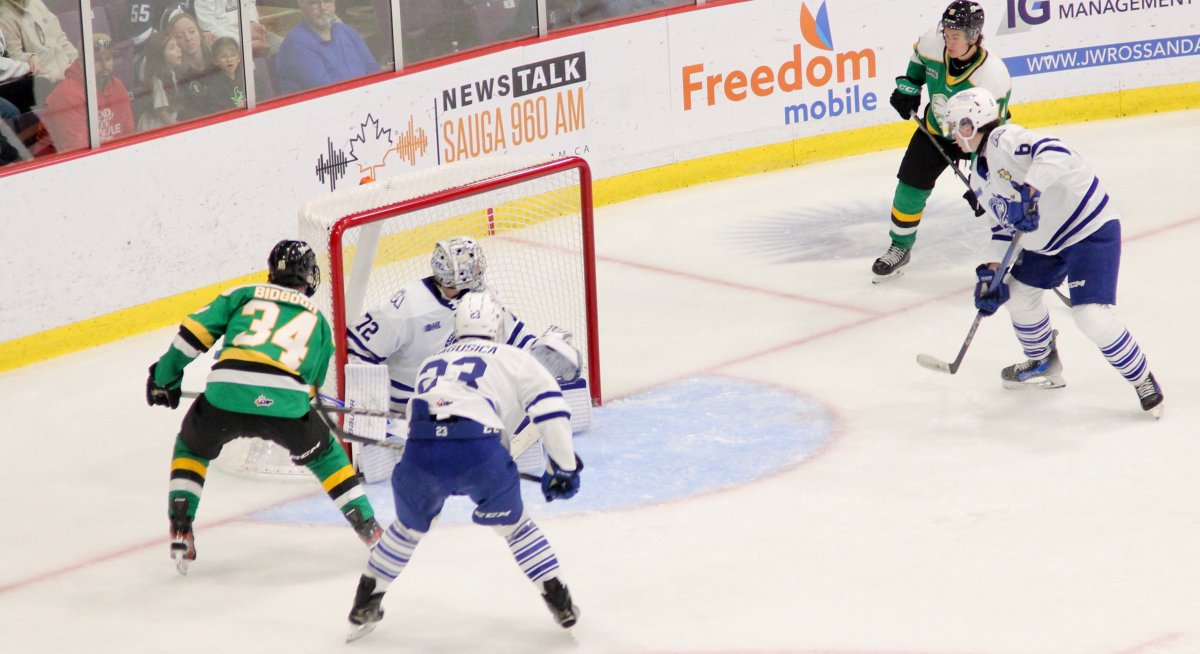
xmin=314 ymin=114 xmax=430 ymax=191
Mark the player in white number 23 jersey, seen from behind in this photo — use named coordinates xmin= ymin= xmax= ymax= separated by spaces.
xmin=347 ymin=290 xmax=583 ymax=641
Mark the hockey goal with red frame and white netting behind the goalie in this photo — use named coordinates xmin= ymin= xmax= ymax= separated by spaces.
xmin=217 ymin=157 xmax=600 ymax=472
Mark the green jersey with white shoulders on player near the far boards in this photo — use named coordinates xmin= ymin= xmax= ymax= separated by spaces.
xmin=905 ymin=28 xmax=1013 ymax=136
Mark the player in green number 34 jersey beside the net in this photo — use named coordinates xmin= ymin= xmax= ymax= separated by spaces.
xmin=146 ymin=240 xmax=382 ymax=575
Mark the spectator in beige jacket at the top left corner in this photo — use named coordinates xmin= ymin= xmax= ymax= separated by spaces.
xmin=0 ymin=0 xmax=79 ymax=104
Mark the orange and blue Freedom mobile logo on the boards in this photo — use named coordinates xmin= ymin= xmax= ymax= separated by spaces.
xmin=680 ymin=2 xmax=878 ymax=125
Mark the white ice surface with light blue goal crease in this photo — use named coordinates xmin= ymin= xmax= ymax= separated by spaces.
xmin=0 ymin=110 xmax=1200 ymax=654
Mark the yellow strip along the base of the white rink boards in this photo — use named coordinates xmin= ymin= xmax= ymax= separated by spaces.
xmin=0 ymin=82 xmax=1200 ymax=372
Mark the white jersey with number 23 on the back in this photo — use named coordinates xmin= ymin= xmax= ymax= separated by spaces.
xmin=412 ymin=337 xmax=575 ymax=470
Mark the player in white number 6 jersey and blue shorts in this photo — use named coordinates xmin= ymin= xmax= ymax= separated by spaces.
xmin=943 ymin=89 xmax=1163 ymax=418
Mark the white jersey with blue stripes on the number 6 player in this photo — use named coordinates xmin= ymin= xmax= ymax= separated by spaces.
xmin=971 ymin=124 xmax=1120 ymax=262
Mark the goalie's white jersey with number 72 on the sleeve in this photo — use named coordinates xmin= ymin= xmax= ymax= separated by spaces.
xmin=346 ymin=277 xmax=535 ymax=413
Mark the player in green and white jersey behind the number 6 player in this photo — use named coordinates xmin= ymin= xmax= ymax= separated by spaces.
xmin=871 ymin=0 xmax=1012 ymax=282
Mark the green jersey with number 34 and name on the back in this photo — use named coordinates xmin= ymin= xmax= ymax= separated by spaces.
xmin=155 ymin=284 xmax=334 ymax=418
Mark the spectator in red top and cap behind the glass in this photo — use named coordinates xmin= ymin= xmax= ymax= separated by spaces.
xmin=42 ymin=34 xmax=133 ymax=152
